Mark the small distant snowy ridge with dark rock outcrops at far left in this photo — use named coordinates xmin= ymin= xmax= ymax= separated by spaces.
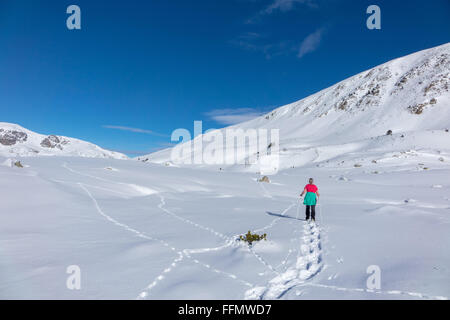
xmin=0 ymin=122 xmax=127 ymax=159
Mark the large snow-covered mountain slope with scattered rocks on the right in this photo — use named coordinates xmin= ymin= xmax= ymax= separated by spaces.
xmin=138 ymin=43 xmax=450 ymax=170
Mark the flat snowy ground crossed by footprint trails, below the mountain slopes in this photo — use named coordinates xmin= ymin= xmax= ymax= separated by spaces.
xmin=0 ymin=154 xmax=450 ymax=299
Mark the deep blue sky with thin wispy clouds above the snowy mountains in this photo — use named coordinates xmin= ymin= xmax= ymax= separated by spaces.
xmin=0 ymin=0 xmax=450 ymax=156
